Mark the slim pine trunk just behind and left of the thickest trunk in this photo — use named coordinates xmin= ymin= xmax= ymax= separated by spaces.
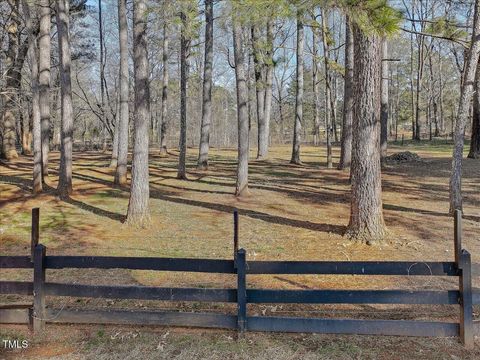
xmin=338 ymin=16 xmax=354 ymax=170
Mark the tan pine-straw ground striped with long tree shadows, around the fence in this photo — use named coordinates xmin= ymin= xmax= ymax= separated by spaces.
xmin=0 ymin=142 xmax=480 ymax=359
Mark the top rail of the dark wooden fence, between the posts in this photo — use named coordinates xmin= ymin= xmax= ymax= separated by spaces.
xmin=0 ymin=256 xmax=460 ymax=276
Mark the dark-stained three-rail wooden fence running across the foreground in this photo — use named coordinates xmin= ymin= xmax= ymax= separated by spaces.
xmin=0 ymin=209 xmax=480 ymax=348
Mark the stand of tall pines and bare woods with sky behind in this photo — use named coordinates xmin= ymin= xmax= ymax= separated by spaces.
xmin=0 ymin=0 xmax=480 ymax=242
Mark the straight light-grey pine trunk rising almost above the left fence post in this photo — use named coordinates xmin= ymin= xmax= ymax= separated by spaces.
xmin=38 ymin=0 xmax=51 ymax=177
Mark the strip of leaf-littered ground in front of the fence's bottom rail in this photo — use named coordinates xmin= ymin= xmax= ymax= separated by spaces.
xmin=0 ymin=326 xmax=480 ymax=360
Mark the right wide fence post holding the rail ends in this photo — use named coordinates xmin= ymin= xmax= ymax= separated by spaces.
xmin=459 ymin=250 xmax=474 ymax=349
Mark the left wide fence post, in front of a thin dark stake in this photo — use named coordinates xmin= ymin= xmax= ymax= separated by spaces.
xmin=33 ymin=244 xmax=46 ymax=334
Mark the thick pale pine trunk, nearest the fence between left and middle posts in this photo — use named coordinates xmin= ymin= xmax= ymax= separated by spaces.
xmin=127 ymin=0 xmax=150 ymax=227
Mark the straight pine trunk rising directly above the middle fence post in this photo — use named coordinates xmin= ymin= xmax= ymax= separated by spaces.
xmin=233 ymin=19 xmax=249 ymax=196
